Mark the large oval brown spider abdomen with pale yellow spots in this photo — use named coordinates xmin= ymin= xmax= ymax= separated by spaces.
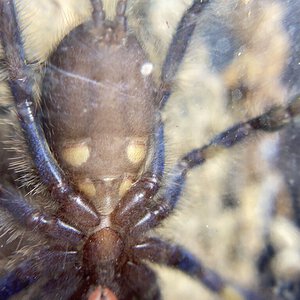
xmin=42 ymin=22 xmax=155 ymax=215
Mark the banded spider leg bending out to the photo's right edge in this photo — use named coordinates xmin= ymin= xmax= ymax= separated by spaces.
xmin=131 ymin=96 xmax=300 ymax=235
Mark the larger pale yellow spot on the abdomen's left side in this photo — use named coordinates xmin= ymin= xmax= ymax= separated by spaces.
xmin=62 ymin=144 xmax=90 ymax=167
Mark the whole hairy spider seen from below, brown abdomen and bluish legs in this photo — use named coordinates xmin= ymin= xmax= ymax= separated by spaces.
xmin=0 ymin=0 xmax=300 ymax=299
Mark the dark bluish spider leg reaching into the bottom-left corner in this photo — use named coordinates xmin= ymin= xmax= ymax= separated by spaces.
xmin=0 ymin=249 xmax=78 ymax=299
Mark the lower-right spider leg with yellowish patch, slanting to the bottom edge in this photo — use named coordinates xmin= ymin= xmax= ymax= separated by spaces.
xmin=132 ymin=238 xmax=260 ymax=300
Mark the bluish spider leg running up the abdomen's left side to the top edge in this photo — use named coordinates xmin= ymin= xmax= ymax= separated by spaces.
xmin=0 ymin=0 xmax=99 ymax=227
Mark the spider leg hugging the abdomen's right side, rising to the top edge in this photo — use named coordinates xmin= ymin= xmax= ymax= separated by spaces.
xmin=112 ymin=0 xmax=208 ymax=232
